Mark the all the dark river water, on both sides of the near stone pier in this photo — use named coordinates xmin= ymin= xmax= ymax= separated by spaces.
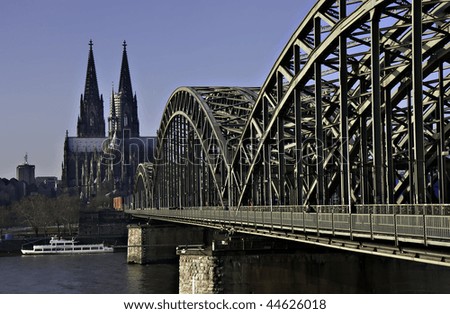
xmin=0 ymin=249 xmax=450 ymax=294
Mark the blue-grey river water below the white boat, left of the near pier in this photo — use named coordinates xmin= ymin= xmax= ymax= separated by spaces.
xmin=0 ymin=252 xmax=178 ymax=294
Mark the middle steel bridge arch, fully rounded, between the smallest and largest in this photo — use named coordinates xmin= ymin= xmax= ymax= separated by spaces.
xmin=152 ymin=87 xmax=258 ymax=208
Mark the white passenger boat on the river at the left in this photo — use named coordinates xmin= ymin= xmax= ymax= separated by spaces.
xmin=21 ymin=237 xmax=114 ymax=255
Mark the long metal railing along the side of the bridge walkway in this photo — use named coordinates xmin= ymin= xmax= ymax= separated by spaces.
xmin=131 ymin=206 xmax=450 ymax=247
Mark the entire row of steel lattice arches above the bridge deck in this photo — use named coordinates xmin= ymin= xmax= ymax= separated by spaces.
xmin=135 ymin=0 xmax=450 ymax=209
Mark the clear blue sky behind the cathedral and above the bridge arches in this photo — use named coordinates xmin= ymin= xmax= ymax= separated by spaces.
xmin=0 ymin=0 xmax=316 ymax=179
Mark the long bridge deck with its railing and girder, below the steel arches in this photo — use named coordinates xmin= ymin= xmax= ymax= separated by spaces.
xmin=127 ymin=207 xmax=450 ymax=266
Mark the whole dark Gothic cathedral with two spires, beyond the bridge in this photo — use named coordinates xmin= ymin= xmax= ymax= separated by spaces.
xmin=61 ymin=40 xmax=156 ymax=198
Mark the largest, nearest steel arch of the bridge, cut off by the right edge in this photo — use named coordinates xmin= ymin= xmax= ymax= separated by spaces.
xmin=232 ymin=0 xmax=450 ymax=210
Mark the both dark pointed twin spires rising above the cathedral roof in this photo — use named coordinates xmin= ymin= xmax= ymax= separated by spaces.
xmin=77 ymin=40 xmax=139 ymax=137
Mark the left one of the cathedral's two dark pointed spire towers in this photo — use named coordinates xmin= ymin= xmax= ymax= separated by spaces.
xmin=77 ymin=40 xmax=105 ymax=137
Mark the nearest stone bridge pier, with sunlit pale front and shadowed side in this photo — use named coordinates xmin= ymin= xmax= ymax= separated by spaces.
xmin=177 ymin=236 xmax=295 ymax=294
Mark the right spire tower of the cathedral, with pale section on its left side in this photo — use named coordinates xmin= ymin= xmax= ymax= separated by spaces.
xmin=108 ymin=41 xmax=139 ymax=138
